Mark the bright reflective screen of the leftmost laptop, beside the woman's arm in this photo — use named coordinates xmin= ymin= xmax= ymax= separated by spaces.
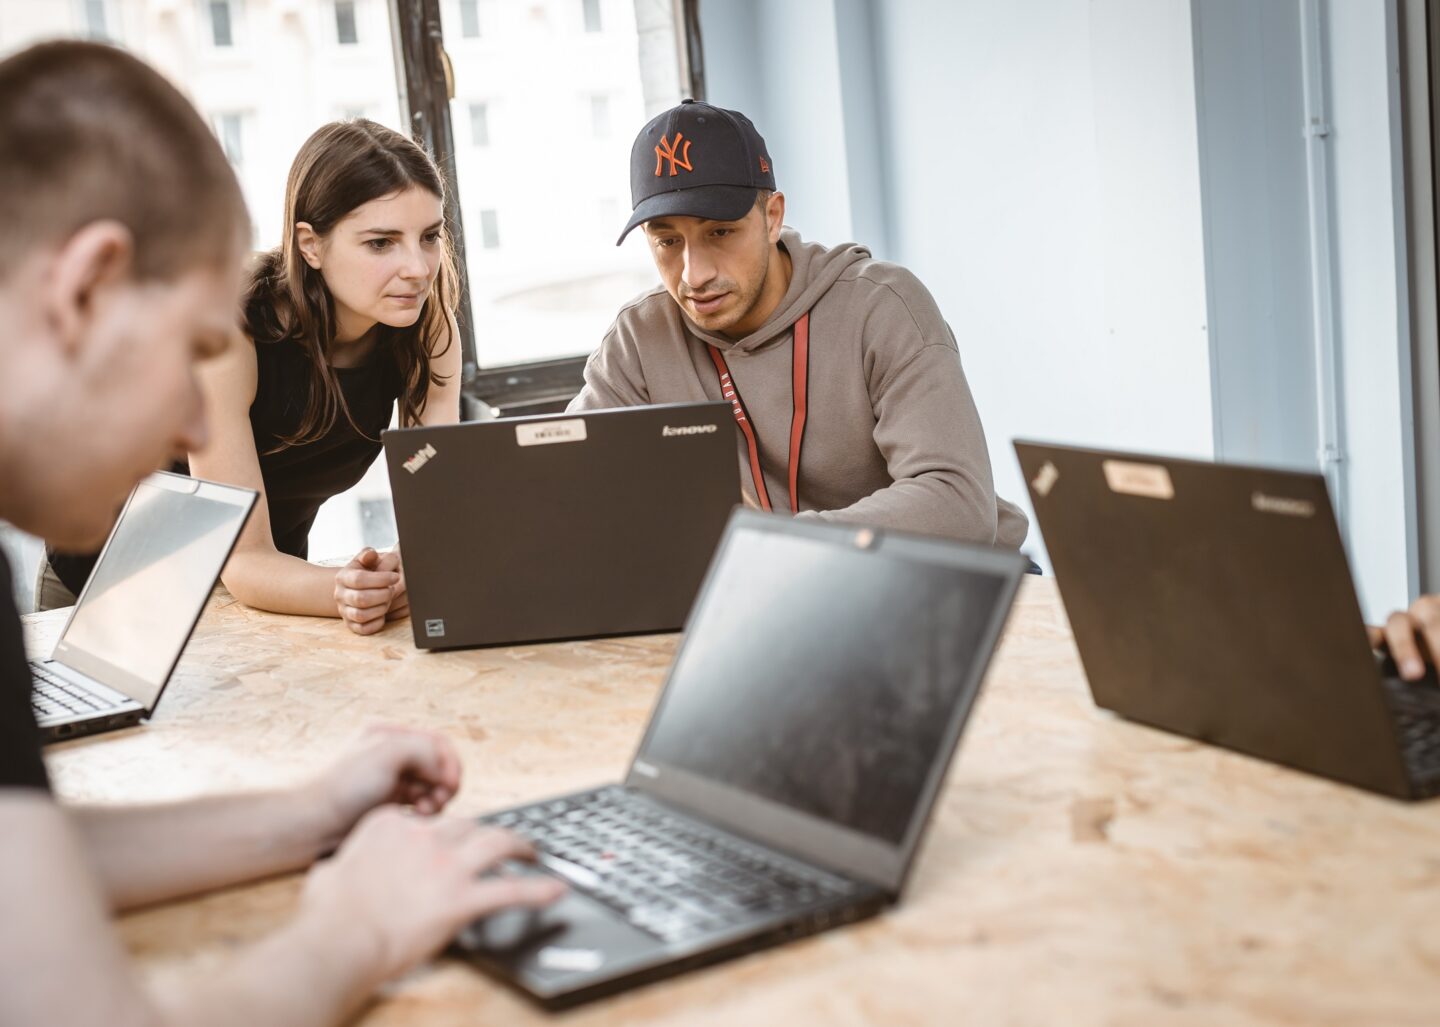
xmin=56 ymin=475 xmax=251 ymax=707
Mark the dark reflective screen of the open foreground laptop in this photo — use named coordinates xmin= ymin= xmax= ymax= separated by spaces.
xmin=639 ymin=529 xmax=1014 ymax=846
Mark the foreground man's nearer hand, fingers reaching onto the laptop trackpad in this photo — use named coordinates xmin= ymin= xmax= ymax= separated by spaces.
xmin=300 ymin=810 xmax=564 ymax=984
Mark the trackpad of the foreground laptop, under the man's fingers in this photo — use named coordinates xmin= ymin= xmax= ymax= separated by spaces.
xmin=455 ymin=892 xmax=665 ymax=985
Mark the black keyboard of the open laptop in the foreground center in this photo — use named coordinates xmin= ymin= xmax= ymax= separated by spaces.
xmin=484 ymin=788 xmax=855 ymax=942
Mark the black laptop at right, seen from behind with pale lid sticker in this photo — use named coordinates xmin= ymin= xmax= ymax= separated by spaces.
xmin=1015 ymin=442 xmax=1440 ymax=799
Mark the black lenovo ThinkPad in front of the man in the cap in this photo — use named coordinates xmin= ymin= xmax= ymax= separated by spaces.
xmin=383 ymin=403 xmax=740 ymax=648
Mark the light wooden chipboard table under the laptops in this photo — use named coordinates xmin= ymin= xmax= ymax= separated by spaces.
xmin=27 ymin=579 xmax=1440 ymax=1027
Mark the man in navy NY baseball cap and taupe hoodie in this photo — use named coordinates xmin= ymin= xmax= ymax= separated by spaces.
xmin=570 ymin=99 xmax=1027 ymax=547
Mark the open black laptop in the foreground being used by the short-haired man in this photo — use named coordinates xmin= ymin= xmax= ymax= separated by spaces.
xmin=459 ymin=510 xmax=1025 ymax=1007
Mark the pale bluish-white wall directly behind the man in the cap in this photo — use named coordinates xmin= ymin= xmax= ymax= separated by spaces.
xmin=701 ymin=0 xmax=1212 ymax=564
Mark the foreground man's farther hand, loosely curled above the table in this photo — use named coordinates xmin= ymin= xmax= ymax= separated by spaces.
xmin=307 ymin=726 xmax=461 ymax=846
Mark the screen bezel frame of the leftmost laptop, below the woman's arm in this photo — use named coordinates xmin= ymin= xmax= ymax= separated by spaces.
xmin=50 ymin=471 xmax=259 ymax=716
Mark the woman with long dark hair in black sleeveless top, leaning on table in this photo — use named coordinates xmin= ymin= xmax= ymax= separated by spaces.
xmin=37 ymin=118 xmax=461 ymax=634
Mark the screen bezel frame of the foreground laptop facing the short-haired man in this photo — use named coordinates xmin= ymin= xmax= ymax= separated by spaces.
xmin=625 ymin=510 xmax=1027 ymax=894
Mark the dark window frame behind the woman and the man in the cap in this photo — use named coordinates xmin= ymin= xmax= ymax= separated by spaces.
xmin=389 ymin=0 xmax=704 ymax=397
